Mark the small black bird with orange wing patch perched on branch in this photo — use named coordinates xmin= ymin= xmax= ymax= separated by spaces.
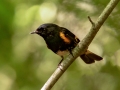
xmin=31 ymin=23 xmax=103 ymax=64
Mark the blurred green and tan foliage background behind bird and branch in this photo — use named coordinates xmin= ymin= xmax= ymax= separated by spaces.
xmin=0 ymin=0 xmax=120 ymax=90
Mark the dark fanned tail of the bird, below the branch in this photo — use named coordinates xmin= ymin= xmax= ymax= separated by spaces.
xmin=80 ymin=50 xmax=103 ymax=64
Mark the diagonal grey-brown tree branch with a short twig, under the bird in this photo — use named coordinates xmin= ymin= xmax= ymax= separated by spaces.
xmin=41 ymin=0 xmax=120 ymax=90
